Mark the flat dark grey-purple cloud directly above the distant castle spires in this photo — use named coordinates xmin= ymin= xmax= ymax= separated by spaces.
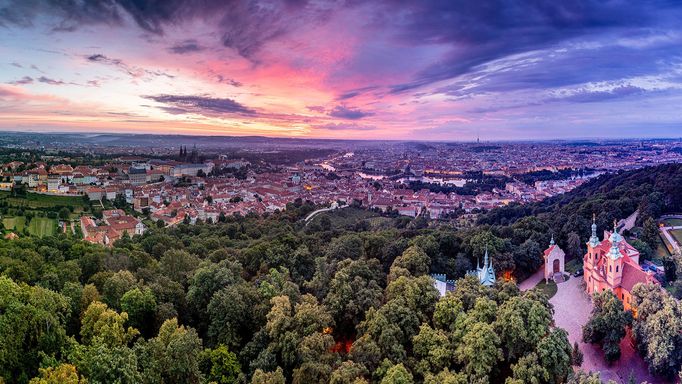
xmin=145 ymin=95 xmax=256 ymax=116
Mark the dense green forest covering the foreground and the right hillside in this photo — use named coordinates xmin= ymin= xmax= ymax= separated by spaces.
xmin=0 ymin=166 xmax=682 ymax=384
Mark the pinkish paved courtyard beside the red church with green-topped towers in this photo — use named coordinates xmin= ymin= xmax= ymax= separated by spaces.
xmin=549 ymin=277 xmax=665 ymax=384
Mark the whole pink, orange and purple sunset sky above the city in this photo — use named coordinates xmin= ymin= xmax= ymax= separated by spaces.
xmin=0 ymin=0 xmax=682 ymax=140
